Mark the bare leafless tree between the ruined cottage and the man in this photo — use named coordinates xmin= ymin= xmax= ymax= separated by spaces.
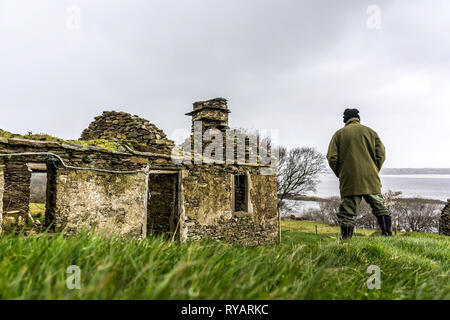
xmin=278 ymin=147 xmax=325 ymax=208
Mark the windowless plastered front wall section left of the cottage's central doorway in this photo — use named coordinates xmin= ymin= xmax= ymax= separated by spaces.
xmin=53 ymin=169 xmax=147 ymax=237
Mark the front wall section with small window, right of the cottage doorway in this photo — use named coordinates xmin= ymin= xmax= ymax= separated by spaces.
xmin=181 ymin=165 xmax=277 ymax=245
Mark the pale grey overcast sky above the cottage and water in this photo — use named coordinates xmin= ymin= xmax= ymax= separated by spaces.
xmin=0 ymin=0 xmax=450 ymax=167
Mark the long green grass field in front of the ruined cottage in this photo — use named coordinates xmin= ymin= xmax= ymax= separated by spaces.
xmin=0 ymin=220 xmax=450 ymax=299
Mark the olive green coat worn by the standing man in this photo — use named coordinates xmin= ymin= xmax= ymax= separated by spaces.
xmin=327 ymin=118 xmax=386 ymax=197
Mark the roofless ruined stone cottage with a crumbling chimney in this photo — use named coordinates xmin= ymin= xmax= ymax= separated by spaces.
xmin=0 ymin=98 xmax=277 ymax=244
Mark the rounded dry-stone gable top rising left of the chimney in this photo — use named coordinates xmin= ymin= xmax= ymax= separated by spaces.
xmin=81 ymin=111 xmax=174 ymax=154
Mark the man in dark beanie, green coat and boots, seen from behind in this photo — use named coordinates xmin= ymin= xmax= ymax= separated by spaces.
xmin=327 ymin=109 xmax=392 ymax=239
